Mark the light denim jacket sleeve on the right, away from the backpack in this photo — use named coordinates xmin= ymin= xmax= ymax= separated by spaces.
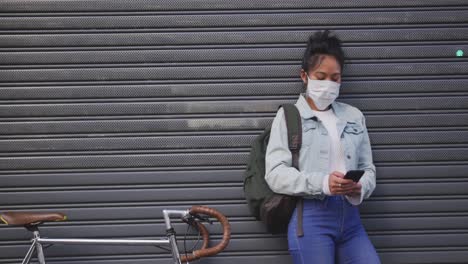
xmin=347 ymin=116 xmax=376 ymax=205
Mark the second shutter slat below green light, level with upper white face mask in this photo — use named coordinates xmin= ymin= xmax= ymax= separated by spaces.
xmin=0 ymin=78 xmax=468 ymax=100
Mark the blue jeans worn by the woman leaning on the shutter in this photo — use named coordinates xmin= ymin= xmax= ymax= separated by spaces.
xmin=288 ymin=196 xmax=380 ymax=264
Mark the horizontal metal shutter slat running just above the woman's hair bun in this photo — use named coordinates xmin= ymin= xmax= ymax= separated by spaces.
xmin=0 ymin=10 xmax=468 ymax=30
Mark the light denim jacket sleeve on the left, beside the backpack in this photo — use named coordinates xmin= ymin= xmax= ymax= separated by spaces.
xmin=265 ymin=109 xmax=323 ymax=196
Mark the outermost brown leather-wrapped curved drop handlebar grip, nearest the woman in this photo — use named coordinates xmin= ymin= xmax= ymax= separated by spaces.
xmin=190 ymin=206 xmax=231 ymax=258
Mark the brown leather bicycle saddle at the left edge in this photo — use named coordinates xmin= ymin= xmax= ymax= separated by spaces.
xmin=0 ymin=212 xmax=67 ymax=225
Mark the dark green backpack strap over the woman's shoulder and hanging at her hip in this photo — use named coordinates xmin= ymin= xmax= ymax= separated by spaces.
xmin=281 ymin=104 xmax=304 ymax=237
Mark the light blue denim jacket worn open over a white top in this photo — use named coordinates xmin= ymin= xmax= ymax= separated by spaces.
xmin=265 ymin=95 xmax=376 ymax=204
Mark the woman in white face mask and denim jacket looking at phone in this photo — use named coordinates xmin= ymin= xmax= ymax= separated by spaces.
xmin=265 ymin=31 xmax=380 ymax=264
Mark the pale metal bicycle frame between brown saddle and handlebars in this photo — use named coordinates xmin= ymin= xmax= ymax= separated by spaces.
xmin=22 ymin=210 xmax=189 ymax=264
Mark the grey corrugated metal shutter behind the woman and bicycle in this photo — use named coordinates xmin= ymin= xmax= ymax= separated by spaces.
xmin=0 ymin=0 xmax=468 ymax=264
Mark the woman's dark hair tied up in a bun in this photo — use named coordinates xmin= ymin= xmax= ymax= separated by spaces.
xmin=302 ymin=30 xmax=345 ymax=72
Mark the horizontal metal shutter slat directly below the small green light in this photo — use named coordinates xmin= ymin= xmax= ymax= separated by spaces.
xmin=0 ymin=61 xmax=468 ymax=82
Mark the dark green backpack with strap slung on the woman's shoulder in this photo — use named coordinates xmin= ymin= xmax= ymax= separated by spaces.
xmin=244 ymin=104 xmax=303 ymax=236
